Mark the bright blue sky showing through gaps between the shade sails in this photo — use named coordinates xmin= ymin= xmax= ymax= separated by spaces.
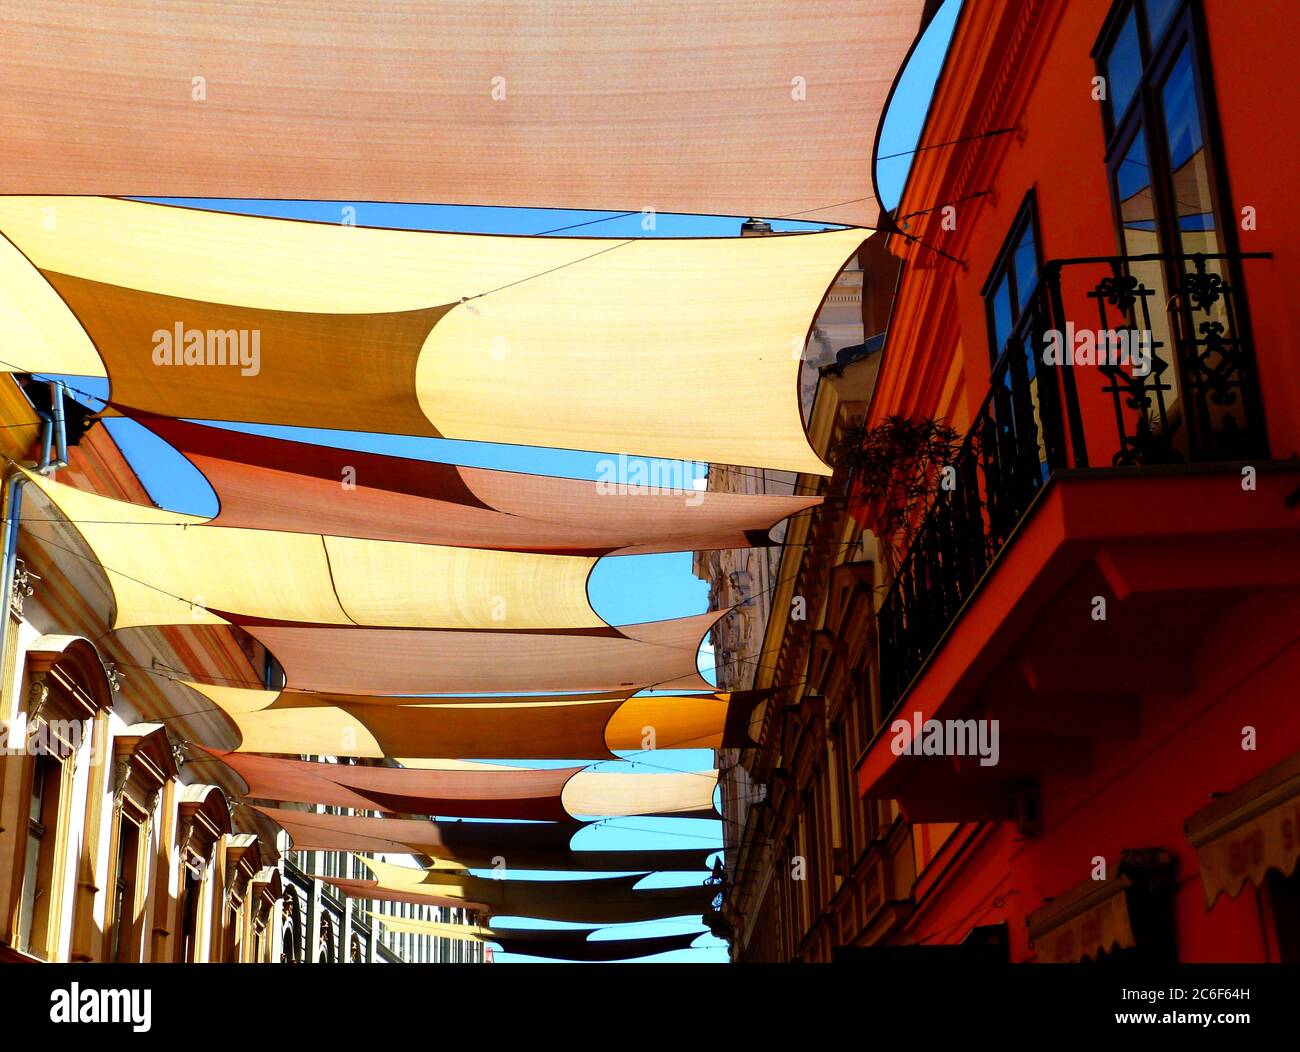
xmin=38 ymin=0 xmax=959 ymax=964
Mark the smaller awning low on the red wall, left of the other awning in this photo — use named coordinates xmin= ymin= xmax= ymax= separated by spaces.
xmin=1026 ymin=874 xmax=1136 ymax=964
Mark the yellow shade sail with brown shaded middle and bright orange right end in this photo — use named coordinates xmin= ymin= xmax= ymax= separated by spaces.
xmin=186 ymin=683 xmax=727 ymax=759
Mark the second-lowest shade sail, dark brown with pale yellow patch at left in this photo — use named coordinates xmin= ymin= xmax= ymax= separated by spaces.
xmin=324 ymin=860 xmax=718 ymax=925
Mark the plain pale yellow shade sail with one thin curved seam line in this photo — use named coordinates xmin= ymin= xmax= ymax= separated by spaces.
xmin=26 ymin=462 xmax=607 ymax=629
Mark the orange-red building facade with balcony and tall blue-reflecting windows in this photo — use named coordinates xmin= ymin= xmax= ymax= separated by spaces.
xmin=855 ymin=0 xmax=1300 ymax=961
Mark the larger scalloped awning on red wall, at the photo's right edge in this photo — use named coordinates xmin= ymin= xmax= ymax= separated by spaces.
xmin=1183 ymin=754 xmax=1300 ymax=909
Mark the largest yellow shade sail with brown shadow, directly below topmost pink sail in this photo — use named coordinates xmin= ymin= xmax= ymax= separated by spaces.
xmin=0 ymin=196 xmax=866 ymax=475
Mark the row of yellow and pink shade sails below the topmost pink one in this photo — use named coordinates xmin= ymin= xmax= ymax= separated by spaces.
xmin=0 ymin=187 xmax=863 ymax=960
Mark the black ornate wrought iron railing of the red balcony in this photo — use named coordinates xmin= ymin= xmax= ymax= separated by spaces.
xmin=878 ymin=254 xmax=1268 ymax=713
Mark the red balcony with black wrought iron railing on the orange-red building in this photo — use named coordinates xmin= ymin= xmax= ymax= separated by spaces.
xmin=859 ymin=254 xmax=1300 ymax=821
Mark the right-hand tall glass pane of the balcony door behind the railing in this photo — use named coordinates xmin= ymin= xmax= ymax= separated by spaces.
xmin=1160 ymin=47 xmax=1219 ymax=252
